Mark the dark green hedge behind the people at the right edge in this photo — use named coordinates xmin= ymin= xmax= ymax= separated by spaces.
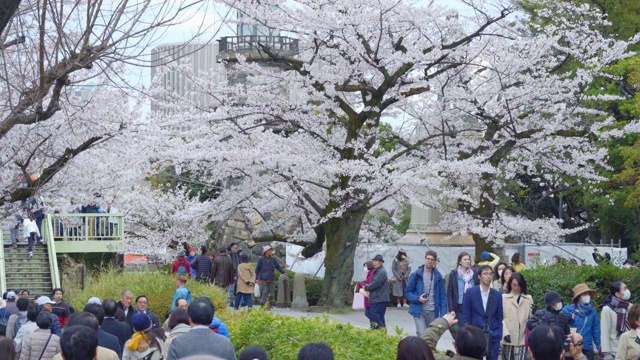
xmin=522 ymin=264 xmax=640 ymax=310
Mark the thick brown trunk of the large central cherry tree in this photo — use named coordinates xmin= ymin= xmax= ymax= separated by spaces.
xmin=320 ymin=210 xmax=366 ymax=308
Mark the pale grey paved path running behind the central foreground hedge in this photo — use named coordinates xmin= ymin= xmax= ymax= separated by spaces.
xmin=271 ymin=307 xmax=455 ymax=351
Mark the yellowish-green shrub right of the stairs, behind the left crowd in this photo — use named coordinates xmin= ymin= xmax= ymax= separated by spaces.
xmin=70 ymin=268 xmax=227 ymax=321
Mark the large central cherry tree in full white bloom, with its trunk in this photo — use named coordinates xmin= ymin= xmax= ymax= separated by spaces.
xmin=148 ymin=0 xmax=637 ymax=307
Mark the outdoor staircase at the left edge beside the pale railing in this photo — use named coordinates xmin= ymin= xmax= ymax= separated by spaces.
xmin=0 ymin=231 xmax=52 ymax=296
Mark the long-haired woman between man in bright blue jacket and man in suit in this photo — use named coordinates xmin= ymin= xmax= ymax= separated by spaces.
xmin=447 ymin=251 xmax=477 ymax=326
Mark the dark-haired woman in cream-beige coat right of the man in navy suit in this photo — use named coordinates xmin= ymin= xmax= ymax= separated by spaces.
xmin=500 ymin=273 xmax=533 ymax=360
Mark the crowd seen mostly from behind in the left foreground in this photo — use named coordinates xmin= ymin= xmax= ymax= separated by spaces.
xmin=0 ymin=282 xmax=340 ymax=360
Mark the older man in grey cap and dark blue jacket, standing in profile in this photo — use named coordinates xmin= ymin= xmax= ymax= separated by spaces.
xmin=364 ymin=254 xmax=389 ymax=330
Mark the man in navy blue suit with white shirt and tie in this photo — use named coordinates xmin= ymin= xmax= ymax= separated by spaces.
xmin=462 ymin=265 xmax=503 ymax=360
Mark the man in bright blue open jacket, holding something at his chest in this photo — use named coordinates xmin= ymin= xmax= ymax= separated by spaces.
xmin=404 ymin=250 xmax=447 ymax=336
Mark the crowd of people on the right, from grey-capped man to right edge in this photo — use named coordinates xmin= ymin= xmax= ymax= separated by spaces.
xmin=358 ymin=250 xmax=640 ymax=360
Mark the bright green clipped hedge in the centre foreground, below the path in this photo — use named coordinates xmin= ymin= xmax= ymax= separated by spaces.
xmin=221 ymin=311 xmax=401 ymax=360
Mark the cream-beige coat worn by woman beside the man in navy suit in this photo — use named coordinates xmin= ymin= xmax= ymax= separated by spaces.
xmin=500 ymin=294 xmax=533 ymax=346
